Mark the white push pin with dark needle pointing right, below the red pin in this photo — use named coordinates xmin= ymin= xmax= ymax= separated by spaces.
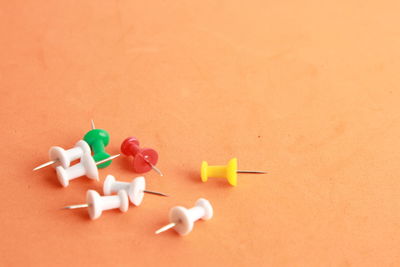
xmin=103 ymin=175 xmax=167 ymax=206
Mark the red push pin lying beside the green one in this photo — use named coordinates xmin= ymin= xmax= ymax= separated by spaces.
xmin=121 ymin=137 xmax=163 ymax=176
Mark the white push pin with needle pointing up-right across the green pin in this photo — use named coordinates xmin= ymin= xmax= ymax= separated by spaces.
xmin=56 ymin=154 xmax=120 ymax=187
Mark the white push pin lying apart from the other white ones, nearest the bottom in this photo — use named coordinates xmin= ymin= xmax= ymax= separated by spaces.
xmin=156 ymin=198 xmax=213 ymax=235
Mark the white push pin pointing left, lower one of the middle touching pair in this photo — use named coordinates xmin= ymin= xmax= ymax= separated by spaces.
xmin=64 ymin=190 xmax=129 ymax=220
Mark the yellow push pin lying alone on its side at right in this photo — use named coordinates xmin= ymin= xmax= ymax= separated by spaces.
xmin=201 ymin=158 xmax=267 ymax=186
